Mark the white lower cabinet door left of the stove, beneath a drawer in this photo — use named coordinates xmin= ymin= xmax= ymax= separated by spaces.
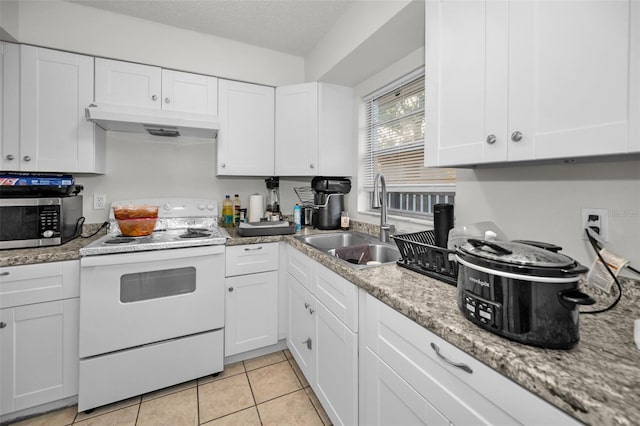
xmin=0 ymin=298 xmax=78 ymax=414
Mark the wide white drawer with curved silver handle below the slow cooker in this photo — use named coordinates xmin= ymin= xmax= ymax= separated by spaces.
xmin=364 ymin=295 xmax=578 ymax=425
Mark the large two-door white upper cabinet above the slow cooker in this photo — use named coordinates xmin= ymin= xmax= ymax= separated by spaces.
xmin=425 ymin=1 xmax=640 ymax=166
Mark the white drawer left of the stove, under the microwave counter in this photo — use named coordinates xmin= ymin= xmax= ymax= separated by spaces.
xmin=0 ymin=260 xmax=80 ymax=308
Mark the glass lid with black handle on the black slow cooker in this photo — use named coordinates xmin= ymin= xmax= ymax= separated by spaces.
xmin=459 ymin=239 xmax=576 ymax=269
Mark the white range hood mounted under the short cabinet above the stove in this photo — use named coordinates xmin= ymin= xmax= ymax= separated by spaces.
xmin=85 ymin=104 xmax=220 ymax=139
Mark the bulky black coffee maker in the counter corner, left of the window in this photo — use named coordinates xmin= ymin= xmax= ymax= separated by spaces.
xmin=311 ymin=176 xmax=351 ymax=229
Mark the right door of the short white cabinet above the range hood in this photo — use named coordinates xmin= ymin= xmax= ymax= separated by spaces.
xmin=162 ymin=69 xmax=218 ymax=115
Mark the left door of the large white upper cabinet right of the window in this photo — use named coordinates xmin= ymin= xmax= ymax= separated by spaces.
xmin=425 ymin=0 xmax=508 ymax=167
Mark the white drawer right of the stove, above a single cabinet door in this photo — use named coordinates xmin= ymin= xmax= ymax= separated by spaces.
xmin=226 ymin=243 xmax=278 ymax=277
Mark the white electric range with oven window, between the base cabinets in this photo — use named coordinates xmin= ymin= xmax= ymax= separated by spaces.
xmin=78 ymin=198 xmax=228 ymax=411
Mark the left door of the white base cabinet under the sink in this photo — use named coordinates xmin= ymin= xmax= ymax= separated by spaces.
xmin=287 ymin=274 xmax=316 ymax=383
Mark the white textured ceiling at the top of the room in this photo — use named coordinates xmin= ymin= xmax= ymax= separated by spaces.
xmin=67 ymin=0 xmax=363 ymax=56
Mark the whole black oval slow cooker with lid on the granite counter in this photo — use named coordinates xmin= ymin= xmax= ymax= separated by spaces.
xmin=456 ymin=239 xmax=595 ymax=349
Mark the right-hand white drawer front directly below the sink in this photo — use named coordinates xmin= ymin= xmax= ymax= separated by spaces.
xmin=313 ymin=261 xmax=358 ymax=333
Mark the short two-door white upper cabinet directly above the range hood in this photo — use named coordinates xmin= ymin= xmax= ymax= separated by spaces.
xmin=95 ymin=58 xmax=218 ymax=115
